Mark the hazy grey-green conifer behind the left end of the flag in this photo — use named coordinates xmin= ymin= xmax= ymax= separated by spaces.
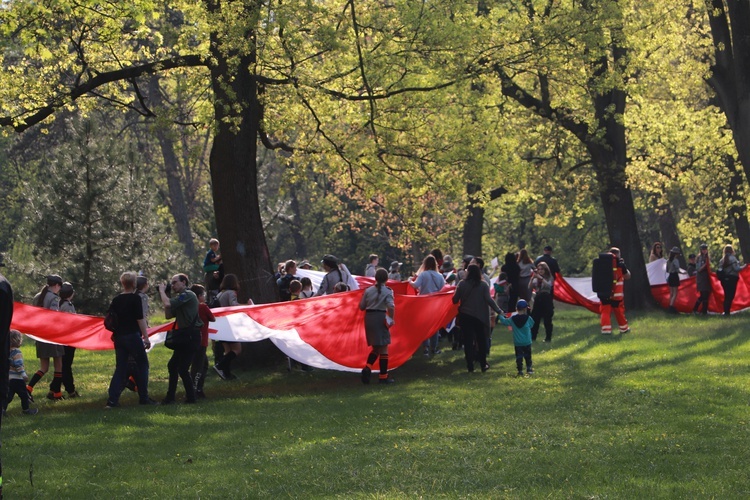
xmin=12 ymin=113 xmax=189 ymax=313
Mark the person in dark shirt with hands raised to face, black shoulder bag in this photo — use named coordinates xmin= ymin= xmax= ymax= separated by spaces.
xmin=159 ymin=274 xmax=203 ymax=404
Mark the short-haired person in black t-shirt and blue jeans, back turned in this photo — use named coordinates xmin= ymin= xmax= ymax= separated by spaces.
xmin=106 ymin=272 xmax=156 ymax=408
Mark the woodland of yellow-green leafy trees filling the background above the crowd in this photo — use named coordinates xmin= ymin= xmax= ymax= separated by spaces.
xmin=0 ymin=0 xmax=750 ymax=314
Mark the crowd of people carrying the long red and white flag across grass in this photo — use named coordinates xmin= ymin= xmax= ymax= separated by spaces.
xmin=3 ymin=239 xmax=744 ymax=415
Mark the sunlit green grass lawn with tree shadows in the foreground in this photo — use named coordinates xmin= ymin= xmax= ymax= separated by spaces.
xmin=2 ymin=307 xmax=750 ymax=499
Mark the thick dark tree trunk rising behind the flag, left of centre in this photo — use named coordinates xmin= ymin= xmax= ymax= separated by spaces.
xmin=208 ymin=1 xmax=278 ymax=304
